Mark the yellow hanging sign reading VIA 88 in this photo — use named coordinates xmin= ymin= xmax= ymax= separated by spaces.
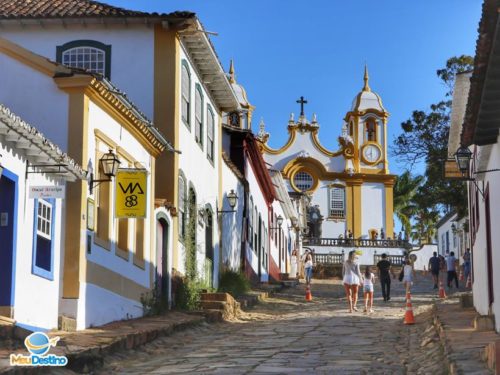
xmin=115 ymin=169 xmax=148 ymax=218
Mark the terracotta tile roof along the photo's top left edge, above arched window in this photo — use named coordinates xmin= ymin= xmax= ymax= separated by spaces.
xmin=0 ymin=0 xmax=194 ymax=20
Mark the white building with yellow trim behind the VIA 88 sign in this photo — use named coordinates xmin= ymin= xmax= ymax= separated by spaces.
xmin=0 ymin=38 xmax=168 ymax=329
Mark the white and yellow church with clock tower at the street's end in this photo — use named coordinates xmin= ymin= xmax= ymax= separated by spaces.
xmin=258 ymin=67 xmax=404 ymax=264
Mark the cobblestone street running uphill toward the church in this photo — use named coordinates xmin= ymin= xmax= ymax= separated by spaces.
xmin=74 ymin=276 xmax=460 ymax=374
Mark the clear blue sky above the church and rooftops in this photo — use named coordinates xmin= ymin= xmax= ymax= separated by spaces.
xmin=108 ymin=0 xmax=482 ymax=173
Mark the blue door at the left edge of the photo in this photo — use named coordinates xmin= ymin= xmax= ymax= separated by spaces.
xmin=0 ymin=170 xmax=17 ymax=313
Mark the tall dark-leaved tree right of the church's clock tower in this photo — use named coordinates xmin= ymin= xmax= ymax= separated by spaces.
xmin=391 ymin=55 xmax=473 ymax=216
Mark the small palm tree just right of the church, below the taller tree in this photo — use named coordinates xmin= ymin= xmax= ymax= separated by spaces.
xmin=394 ymin=171 xmax=424 ymax=234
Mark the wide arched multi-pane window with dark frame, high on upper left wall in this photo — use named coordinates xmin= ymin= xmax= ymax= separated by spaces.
xmin=56 ymin=40 xmax=111 ymax=79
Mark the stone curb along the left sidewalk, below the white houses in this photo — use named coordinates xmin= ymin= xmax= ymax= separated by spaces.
xmin=0 ymin=316 xmax=206 ymax=375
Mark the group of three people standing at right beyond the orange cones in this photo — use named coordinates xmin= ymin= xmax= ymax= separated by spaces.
xmin=429 ymin=249 xmax=471 ymax=289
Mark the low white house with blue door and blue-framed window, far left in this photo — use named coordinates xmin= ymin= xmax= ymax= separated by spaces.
xmin=0 ymin=103 xmax=85 ymax=330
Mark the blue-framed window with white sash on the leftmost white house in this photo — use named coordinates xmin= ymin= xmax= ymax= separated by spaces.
xmin=33 ymin=199 xmax=55 ymax=279
